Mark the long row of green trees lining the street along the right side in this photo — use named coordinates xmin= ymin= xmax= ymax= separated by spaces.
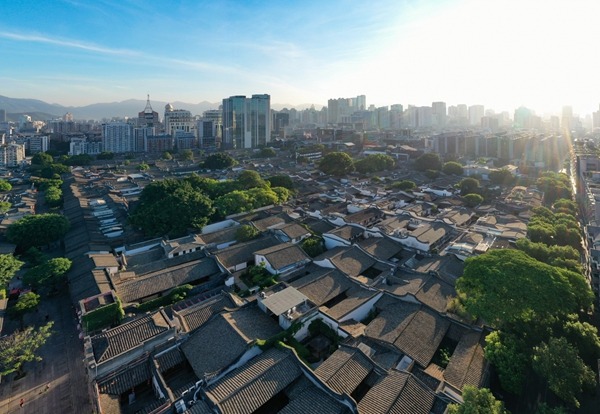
xmin=456 ymin=180 xmax=600 ymax=407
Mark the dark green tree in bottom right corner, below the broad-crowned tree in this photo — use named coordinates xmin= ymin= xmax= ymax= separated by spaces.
xmin=533 ymin=338 xmax=596 ymax=408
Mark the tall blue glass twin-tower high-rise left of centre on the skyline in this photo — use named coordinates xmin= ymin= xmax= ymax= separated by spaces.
xmin=223 ymin=94 xmax=271 ymax=148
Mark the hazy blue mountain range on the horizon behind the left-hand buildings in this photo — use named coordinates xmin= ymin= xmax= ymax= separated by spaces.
xmin=0 ymin=95 xmax=322 ymax=121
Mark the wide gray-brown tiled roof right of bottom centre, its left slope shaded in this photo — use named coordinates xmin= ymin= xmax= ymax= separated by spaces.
xmin=365 ymin=301 xmax=450 ymax=367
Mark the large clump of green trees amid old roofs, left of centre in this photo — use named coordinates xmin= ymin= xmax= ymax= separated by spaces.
xmin=130 ymin=171 xmax=291 ymax=237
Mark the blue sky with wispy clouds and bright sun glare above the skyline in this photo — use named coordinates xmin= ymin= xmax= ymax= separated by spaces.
xmin=0 ymin=0 xmax=600 ymax=115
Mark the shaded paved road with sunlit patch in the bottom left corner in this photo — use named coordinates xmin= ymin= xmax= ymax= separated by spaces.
xmin=0 ymin=292 xmax=92 ymax=414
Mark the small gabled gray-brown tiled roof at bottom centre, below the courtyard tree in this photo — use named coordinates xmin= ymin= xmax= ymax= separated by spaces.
xmin=315 ymin=347 xmax=373 ymax=395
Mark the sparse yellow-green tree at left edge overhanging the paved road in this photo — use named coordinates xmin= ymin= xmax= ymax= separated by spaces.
xmin=0 ymin=322 xmax=54 ymax=376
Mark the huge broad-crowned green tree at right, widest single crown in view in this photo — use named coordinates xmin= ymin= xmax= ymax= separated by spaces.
xmin=456 ymin=250 xmax=593 ymax=329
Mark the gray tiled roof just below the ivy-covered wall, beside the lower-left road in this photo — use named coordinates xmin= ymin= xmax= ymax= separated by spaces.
xmin=91 ymin=311 xmax=170 ymax=363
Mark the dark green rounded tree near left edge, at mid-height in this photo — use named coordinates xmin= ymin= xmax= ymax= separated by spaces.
xmin=6 ymin=213 xmax=70 ymax=250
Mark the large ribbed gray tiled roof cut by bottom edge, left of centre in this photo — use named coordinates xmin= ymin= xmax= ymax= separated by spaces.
xmin=206 ymin=348 xmax=302 ymax=414
